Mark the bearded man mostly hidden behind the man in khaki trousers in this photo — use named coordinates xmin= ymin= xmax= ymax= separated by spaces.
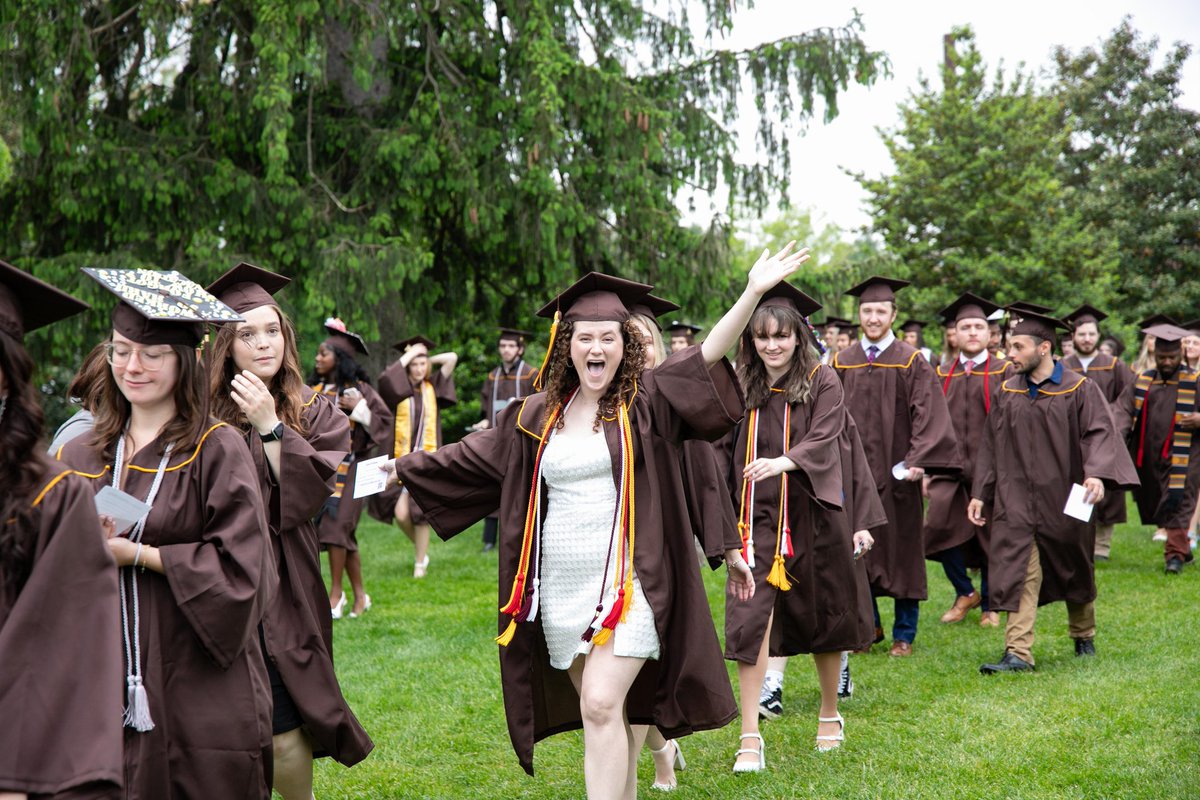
xmin=1062 ymin=303 xmax=1134 ymax=561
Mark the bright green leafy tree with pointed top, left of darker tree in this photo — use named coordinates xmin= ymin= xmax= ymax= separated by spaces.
xmin=857 ymin=28 xmax=1116 ymax=319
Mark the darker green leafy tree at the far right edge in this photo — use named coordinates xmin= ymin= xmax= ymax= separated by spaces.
xmin=1054 ymin=18 xmax=1200 ymax=320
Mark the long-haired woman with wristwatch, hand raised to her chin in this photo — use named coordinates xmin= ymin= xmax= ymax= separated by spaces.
xmin=206 ymin=264 xmax=372 ymax=800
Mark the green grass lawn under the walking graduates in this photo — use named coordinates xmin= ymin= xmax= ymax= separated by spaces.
xmin=316 ymin=517 xmax=1200 ymax=800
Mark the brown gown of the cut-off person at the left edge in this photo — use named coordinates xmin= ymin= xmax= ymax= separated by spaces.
xmin=0 ymin=453 xmax=125 ymax=798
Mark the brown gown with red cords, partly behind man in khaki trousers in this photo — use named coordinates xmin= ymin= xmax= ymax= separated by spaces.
xmin=925 ymin=356 xmax=1013 ymax=567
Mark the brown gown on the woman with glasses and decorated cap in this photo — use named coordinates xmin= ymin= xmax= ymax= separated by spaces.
xmin=60 ymin=421 xmax=274 ymax=800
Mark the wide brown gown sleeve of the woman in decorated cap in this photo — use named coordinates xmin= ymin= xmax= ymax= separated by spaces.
xmin=158 ymin=426 xmax=270 ymax=669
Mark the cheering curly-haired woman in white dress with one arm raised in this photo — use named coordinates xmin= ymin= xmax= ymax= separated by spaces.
xmin=396 ymin=253 xmax=808 ymax=800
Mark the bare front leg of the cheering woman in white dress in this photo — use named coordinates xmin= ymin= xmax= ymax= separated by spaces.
xmin=568 ymin=642 xmax=646 ymax=800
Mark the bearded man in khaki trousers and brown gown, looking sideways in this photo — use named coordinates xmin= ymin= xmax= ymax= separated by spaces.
xmin=967 ymin=311 xmax=1138 ymax=674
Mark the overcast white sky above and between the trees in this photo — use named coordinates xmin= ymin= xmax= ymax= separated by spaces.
xmin=696 ymin=0 xmax=1200 ymax=236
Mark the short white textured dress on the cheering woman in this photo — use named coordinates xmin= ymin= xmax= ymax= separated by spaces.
xmin=538 ymin=432 xmax=659 ymax=669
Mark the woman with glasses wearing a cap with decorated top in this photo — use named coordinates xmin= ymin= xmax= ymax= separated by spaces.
xmin=59 ymin=270 xmax=275 ymax=800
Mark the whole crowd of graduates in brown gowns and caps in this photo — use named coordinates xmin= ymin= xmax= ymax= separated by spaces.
xmin=0 ymin=248 xmax=1200 ymax=800
